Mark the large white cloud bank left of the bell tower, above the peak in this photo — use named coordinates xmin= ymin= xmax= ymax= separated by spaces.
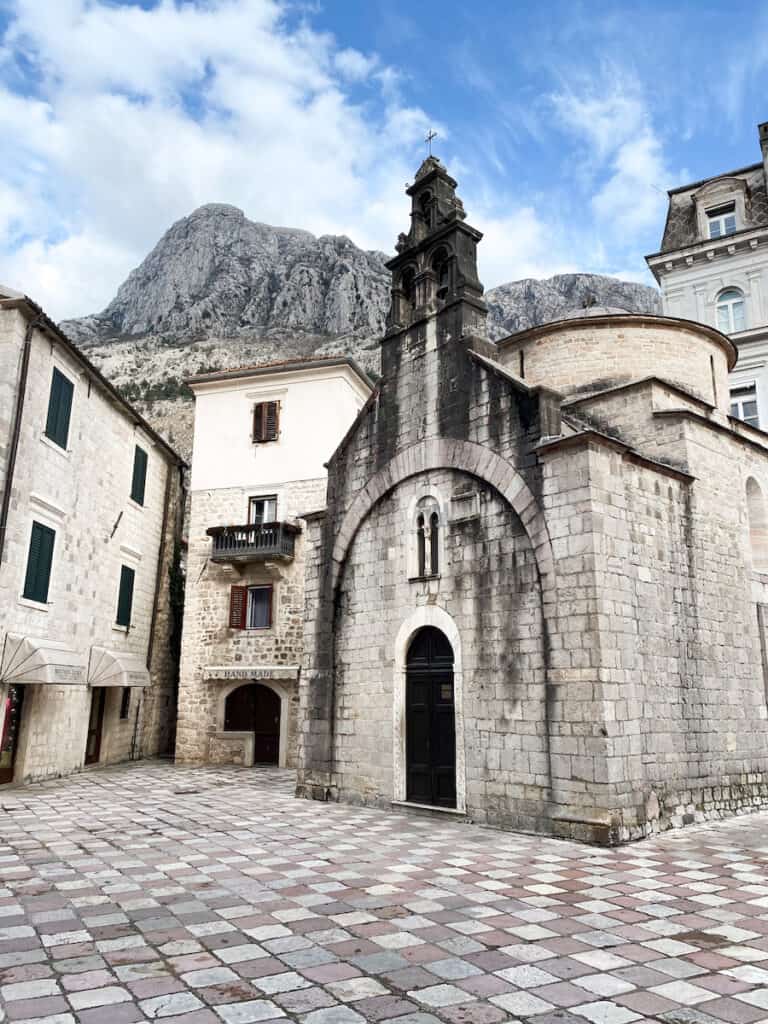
xmin=0 ymin=0 xmax=429 ymax=317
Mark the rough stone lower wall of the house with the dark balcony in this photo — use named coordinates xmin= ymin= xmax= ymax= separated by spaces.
xmin=176 ymin=478 xmax=326 ymax=764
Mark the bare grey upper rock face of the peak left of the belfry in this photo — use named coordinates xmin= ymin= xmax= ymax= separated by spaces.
xmin=61 ymin=204 xmax=389 ymax=345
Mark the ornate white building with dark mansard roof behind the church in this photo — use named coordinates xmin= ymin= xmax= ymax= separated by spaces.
xmin=647 ymin=122 xmax=768 ymax=430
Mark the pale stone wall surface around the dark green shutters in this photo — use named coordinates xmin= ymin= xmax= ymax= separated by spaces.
xmin=0 ymin=310 xmax=179 ymax=780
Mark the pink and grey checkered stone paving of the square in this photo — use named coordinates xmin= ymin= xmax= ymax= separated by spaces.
xmin=0 ymin=763 xmax=768 ymax=1024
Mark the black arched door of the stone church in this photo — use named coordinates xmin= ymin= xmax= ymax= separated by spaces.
xmin=406 ymin=626 xmax=456 ymax=807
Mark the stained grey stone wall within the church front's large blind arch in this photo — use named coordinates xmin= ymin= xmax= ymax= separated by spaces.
xmin=335 ymin=471 xmax=549 ymax=827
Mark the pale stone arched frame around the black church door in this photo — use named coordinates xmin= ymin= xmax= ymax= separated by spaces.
xmin=392 ymin=604 xmax=467 ymax=813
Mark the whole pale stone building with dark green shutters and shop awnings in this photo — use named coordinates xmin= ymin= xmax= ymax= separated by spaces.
xmin=0 ymin=289 xmax=183 ymax=783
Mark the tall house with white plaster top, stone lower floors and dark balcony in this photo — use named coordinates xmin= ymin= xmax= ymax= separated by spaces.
xmin=176 ymin=356 xmax=372 ymax=765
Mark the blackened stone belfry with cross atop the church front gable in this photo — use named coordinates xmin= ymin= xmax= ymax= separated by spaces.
xmin=387 ymin=153 xmax=486 ymax=336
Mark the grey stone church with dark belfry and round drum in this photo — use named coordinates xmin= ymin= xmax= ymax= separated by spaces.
xmin=298 ymin=157 xmax=768 ymax=843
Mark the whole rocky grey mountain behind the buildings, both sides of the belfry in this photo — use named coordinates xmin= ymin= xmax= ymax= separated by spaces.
xmin=61 ymin=204 xmax=660 ymax=456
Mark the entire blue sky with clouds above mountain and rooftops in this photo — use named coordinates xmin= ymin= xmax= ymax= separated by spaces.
xmin=0 ymin=0 xmax=768 ymax=318
